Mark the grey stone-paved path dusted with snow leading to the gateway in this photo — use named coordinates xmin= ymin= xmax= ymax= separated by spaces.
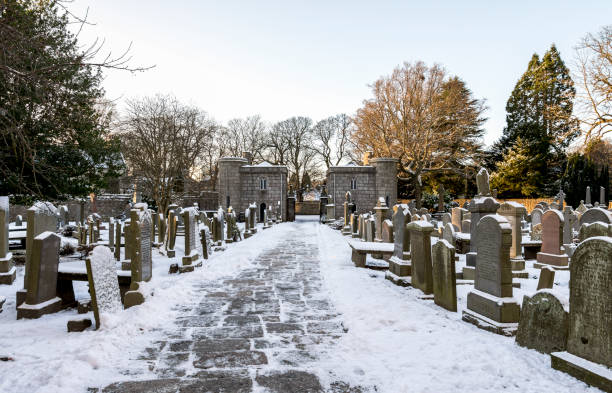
xmin=102 ymin=222 xmax=362 ymax=393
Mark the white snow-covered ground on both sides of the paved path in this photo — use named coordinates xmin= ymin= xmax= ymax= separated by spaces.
xmin=0 ymin=220 xmax=598 ymax=393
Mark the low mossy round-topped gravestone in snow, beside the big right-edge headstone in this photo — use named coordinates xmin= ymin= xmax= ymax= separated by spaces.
xmin=516 ymin=292 xmax=568 ymax=353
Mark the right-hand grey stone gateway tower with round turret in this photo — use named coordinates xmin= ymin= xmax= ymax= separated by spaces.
xmin=327 ymin=153 xmax=398 ymax=217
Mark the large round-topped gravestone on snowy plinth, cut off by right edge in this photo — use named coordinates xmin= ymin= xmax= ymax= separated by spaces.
xmin=551 ymin=237 xmax=612 ymax=391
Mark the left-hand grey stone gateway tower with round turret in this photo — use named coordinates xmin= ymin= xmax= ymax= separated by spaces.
xmin=217 ymin=152 xmax=288 ymax=221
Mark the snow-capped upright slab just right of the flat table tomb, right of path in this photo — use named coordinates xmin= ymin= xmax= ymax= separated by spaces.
xmin=406 ymin=221 xmax=434 ymax=295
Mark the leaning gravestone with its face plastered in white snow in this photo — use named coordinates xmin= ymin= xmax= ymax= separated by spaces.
xmin=85 ymin=246 xmax=123 ymax=329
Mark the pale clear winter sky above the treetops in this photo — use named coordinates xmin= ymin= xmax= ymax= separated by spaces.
xmin=69 ymin=0 xmax=612 ymax=144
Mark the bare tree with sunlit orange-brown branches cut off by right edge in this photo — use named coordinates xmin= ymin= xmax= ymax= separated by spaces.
xmin=575 ymin=25 xmax=612 ymax=143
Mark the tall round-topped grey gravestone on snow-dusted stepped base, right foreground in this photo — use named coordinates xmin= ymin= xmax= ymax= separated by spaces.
xmin=462 ymin=214 xmax=520 ymax=336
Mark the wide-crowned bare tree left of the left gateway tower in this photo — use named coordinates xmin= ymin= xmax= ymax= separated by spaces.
xmin=121 ymin=95 xmax=218 ymax=212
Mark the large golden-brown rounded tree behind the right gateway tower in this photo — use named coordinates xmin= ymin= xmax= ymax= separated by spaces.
xmin=353 ymin=62 xmax=485 ymax=206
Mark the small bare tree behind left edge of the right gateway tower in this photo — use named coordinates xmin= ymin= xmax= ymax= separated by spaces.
xmin=312 ymin=113 xmax=353 ymax=169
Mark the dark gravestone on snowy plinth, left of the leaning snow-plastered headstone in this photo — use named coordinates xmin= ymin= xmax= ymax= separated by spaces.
xmin=17 ymin=232 xmax=62 ymax=319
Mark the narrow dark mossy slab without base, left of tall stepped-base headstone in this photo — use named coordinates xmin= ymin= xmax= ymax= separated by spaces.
xmin=432 ymin=237 xmax=457 ymax=312
